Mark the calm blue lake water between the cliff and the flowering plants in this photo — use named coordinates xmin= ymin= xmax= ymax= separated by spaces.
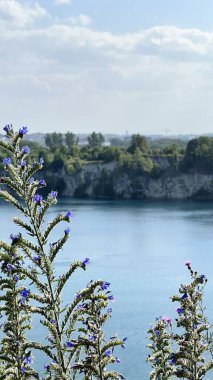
xmin=0 ymin=199 xmax=213 ymax=380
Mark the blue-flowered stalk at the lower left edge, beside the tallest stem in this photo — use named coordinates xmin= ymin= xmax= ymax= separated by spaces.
xmin=0 ymin=239 xmax=38 ymax=380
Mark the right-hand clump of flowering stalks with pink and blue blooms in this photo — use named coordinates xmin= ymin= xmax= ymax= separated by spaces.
xmin=148 ymin=261 xmax=213 ymax=380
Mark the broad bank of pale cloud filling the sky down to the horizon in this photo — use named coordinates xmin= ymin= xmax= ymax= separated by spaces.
xmin=0 ymin=8 xmax=213 ymax=133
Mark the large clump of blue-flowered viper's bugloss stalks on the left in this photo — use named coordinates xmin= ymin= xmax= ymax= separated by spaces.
xmin=0 ymin=125 xmax=125 ymax=380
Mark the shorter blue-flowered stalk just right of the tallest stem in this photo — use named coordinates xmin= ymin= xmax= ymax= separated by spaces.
xmin=71 ymin=282 xmax=127 ymax=380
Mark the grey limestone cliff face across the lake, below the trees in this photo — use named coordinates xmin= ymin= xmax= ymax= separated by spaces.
xmin=49 ymin=163 xmax=213 ymax=200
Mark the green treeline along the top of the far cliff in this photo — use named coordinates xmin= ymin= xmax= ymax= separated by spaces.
xmin=0 ymin=132 xmax=213 ymax=193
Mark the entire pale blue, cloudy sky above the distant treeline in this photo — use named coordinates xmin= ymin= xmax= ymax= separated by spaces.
xmin=0 ymin=0 xmax=213 ymax=135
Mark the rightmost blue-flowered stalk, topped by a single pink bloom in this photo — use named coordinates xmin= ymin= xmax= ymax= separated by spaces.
xmin=172 ymin=261 xmax=213 ymax=380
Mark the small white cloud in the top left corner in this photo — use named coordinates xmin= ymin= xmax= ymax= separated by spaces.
xmin=0 ymin=0 xmax=47 ymax=28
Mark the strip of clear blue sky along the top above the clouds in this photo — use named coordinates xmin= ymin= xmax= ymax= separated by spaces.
xmin=47 ymin=0 xmax=213 ymax=33
